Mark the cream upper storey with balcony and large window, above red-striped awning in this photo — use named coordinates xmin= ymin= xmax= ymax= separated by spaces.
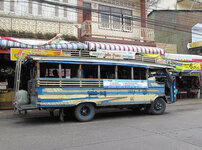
xmin=81 ymin=0 xmax=156 ymax=46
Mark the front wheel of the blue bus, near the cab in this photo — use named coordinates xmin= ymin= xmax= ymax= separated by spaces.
xmin=149 ymin=98 xmax=166 ymax=115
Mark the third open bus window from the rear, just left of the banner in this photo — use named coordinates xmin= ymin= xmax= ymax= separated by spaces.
xmin=82 ymin=65 xmax=98 ymax=79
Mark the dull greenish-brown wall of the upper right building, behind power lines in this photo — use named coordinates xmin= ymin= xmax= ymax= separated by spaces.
xmin=148 ymin=10 xmax=202 ymax=54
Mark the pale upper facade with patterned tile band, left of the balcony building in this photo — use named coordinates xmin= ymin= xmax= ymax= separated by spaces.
xmin=0 ymin=0 xmax=78 ymax=37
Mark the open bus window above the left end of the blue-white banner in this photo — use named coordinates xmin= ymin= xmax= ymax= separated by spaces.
xmin=100 ymin=65 xmax=116 ymax=79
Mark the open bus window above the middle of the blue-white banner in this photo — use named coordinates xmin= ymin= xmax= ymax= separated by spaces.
xmin=118 ymin=66 xmax=132 ymax=79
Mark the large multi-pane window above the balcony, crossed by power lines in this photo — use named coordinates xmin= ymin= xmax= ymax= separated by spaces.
xmin=99 ymin=5 xmax=132 ymax=32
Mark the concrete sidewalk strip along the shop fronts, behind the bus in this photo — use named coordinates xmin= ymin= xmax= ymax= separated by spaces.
xmin=0 ymin=99 xmax=202 ymax=119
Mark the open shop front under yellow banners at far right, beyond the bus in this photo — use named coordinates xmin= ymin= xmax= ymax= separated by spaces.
xmin=168 ymin=60 xmax=201 ymax=99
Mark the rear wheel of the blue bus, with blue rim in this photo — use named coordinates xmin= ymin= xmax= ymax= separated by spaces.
xmin=74 ymin=103 xmax=95 ymax=122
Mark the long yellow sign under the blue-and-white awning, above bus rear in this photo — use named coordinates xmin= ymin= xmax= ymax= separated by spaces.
xmin=10 ymin=48 xmax=65 ymax=61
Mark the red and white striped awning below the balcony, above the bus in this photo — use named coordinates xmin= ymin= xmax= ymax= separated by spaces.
xmin=86 ymin=42 xmax=165 ymax=55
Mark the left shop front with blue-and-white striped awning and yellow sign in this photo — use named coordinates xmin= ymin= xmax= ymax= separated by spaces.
xmin=0 ymin=38 xmax=87 ymax=109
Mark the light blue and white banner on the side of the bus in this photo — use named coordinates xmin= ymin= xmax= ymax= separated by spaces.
xmin=103 ymin=79 xmax=148 ymax=88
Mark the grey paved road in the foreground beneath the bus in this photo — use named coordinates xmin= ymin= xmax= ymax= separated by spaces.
xmin=0 ymin=100 xmax=202 ymax=150
